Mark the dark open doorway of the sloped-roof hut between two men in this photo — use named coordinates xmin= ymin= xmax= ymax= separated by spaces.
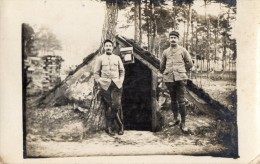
xmin=122 ymin=59 xmax=152 ymax=131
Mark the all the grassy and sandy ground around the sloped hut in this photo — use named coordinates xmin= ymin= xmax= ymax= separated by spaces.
xmin=26 ymin=78 xmax=236 ymax=157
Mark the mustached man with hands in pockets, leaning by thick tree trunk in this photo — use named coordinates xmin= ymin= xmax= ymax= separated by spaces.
xmin=94 ymin=39 xmax=125 ymax=135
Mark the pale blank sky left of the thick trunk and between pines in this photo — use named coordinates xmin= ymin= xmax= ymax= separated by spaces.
xmin=20 ymin=0 xmax=234 ymax=67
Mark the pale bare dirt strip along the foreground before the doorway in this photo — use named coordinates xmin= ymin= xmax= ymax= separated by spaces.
xmin=27 ymin=131 xmax=226 ymax=157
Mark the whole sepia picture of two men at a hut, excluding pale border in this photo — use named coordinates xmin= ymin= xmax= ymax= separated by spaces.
xmin=20 ymin=0 xmax=240 ymax=158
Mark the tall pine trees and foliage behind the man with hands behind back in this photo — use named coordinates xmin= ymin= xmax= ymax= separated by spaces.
xmin=102 ymin=0 xmax=237 ymax=70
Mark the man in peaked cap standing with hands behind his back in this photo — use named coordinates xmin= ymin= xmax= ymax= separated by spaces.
xmin=160 ymin=31 xmax=193 ymax=132
